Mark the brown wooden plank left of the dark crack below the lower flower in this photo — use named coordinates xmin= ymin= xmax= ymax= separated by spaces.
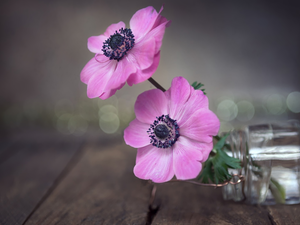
xmin=26 ymin=141 xmax=150 ymax=225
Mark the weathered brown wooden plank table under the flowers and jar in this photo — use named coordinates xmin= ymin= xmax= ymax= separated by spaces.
xmin=0 ymin=129 xmax=300 ymax=225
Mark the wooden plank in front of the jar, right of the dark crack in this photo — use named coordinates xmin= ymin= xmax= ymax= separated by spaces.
xmin=152 ymin=182 xmax=271 ymax=225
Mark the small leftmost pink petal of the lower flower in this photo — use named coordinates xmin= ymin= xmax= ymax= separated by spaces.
xmin=124 ymin=119 xmax=150 ymax=148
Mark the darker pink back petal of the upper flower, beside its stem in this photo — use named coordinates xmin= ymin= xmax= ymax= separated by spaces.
xmin=127 ymin=51 xmax=160 ymax=86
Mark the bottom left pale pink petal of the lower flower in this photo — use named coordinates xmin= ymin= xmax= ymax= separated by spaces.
xmin=133 ymin=145 xmax=174 ymax=183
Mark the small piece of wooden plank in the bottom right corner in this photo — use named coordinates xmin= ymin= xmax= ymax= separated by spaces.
xmin=268 ymin=204 xmax=300 ymax=225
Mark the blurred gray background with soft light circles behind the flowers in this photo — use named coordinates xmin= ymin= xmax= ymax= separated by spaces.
xmin=0 ymin=0 xmax=300 ymax=135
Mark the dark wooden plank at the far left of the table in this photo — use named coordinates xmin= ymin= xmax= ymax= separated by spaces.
xmin=0 ymin=136 xmax=79 ymax=225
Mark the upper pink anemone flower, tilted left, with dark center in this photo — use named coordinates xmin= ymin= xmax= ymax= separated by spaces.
xmin=80 ymin=6 xmax=171 ymax=99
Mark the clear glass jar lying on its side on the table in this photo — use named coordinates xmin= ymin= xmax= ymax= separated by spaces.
xmin=222 ymin=121 xmax=300 ymax=205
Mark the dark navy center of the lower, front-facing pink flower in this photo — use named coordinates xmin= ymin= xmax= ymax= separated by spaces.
xmin=147 ymin=115 xmax=180 ymax=148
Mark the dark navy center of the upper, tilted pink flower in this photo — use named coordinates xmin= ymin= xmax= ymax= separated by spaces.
xmin=102 ymin=28 xmax=134 ymax=61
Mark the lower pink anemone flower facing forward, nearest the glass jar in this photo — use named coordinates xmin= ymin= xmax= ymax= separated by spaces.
xmin=124 ymin=77 xmax=220 ymax=183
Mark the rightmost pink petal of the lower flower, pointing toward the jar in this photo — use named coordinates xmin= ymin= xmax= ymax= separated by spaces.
xmin=179 ymin=109 xmax=220 ymax=143
